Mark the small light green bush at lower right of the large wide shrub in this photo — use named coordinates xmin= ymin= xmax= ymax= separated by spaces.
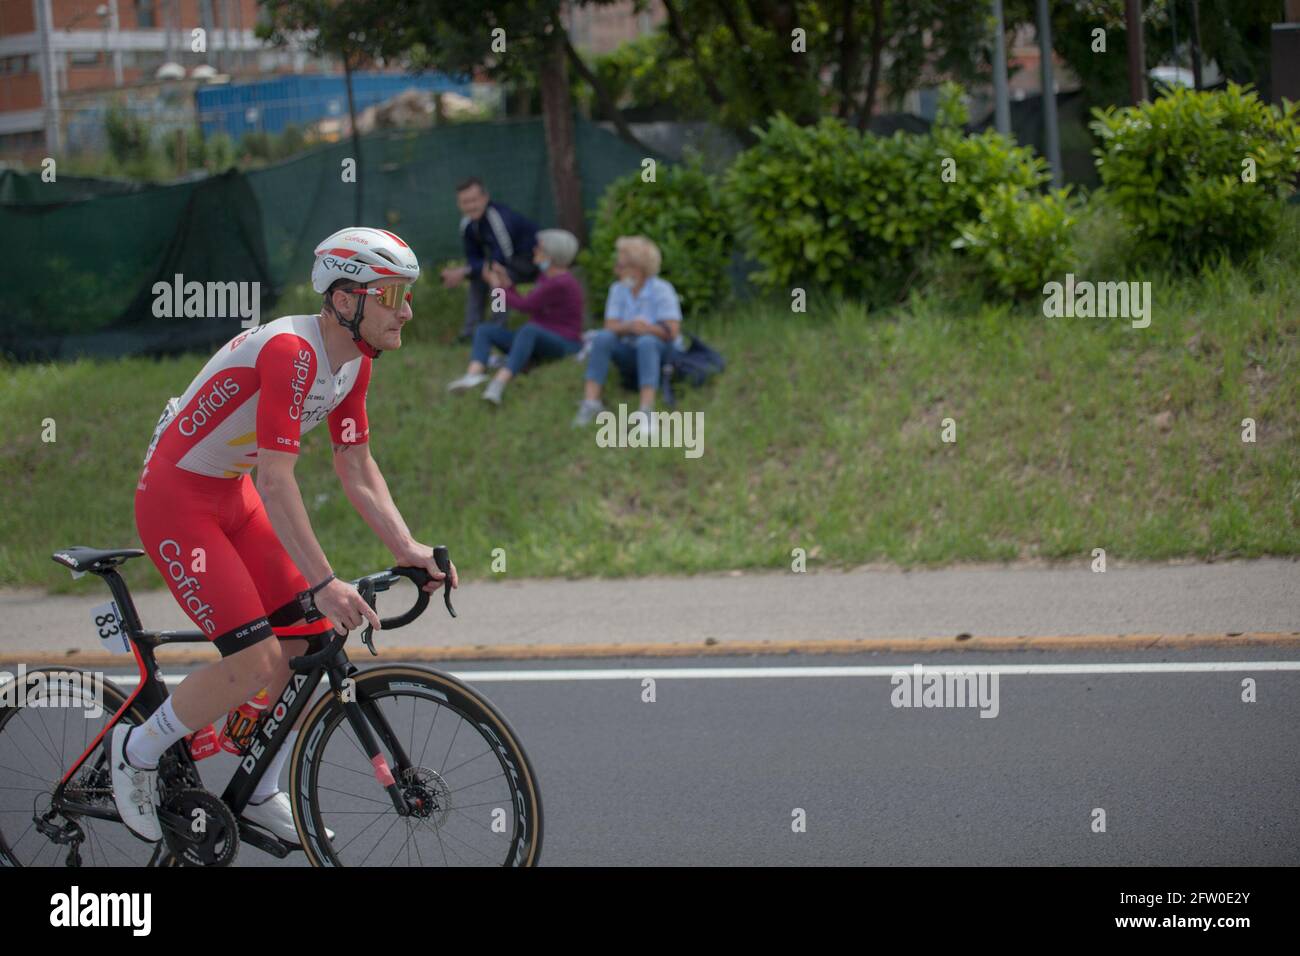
xmin=953 ymin=183 xmax=1078 ymax=298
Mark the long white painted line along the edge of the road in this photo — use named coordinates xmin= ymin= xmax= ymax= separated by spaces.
xmin=96 ymin=661 xmax=1300 ymax=687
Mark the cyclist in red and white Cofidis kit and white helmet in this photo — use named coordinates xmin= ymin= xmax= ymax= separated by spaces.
xmin=109 ymin=226 xmax=458 ymax=844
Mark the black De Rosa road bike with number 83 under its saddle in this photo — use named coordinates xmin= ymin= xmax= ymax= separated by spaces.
xmin=0 ymin=546 xmax=542 ymax=866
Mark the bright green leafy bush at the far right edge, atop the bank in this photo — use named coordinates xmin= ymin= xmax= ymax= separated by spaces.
xmin=1091 ymin=83 xmax=1300 ymax=264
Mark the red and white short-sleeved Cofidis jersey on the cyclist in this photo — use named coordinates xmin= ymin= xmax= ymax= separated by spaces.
xmin=144 ymin=315 xmax=372 ymax=479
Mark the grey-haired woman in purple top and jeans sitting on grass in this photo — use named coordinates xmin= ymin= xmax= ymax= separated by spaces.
xmin=447 ymin=229 xmax=582 ymax=405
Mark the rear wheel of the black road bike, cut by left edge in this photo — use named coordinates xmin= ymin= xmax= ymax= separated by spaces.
xmin=0 ymin=667 xmax=155 ymax=866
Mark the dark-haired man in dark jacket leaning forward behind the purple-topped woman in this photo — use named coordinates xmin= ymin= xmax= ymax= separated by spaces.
xmin=442 ymin=177 xmax=537 ymax=339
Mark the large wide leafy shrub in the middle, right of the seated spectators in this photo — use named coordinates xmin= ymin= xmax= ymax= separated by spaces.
xmin=725 ymin=86 xmax=1049 ymax=298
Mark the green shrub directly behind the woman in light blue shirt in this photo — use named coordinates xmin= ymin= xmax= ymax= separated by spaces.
xmin=579 ymin=163 xmax=732 ymax=319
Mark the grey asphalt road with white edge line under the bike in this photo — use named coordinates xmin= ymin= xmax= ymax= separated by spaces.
xmin=15 ymin=648 xmax=1284 ymax=866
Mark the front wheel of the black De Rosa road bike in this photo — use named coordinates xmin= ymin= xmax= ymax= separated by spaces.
xmin=289 ymin=666 xmax=542 ymax=866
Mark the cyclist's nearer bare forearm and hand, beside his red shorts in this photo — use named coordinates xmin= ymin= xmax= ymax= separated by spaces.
xmin=257 ymin=447 xmax=380 ymax=630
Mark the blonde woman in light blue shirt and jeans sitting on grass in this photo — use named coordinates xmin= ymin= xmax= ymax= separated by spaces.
xmin=573 ymin=235 xmax=681 ymax=427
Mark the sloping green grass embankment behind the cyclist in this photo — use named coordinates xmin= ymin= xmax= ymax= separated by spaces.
xmin=0 ymin=209 xmax=1300 ymax=588
